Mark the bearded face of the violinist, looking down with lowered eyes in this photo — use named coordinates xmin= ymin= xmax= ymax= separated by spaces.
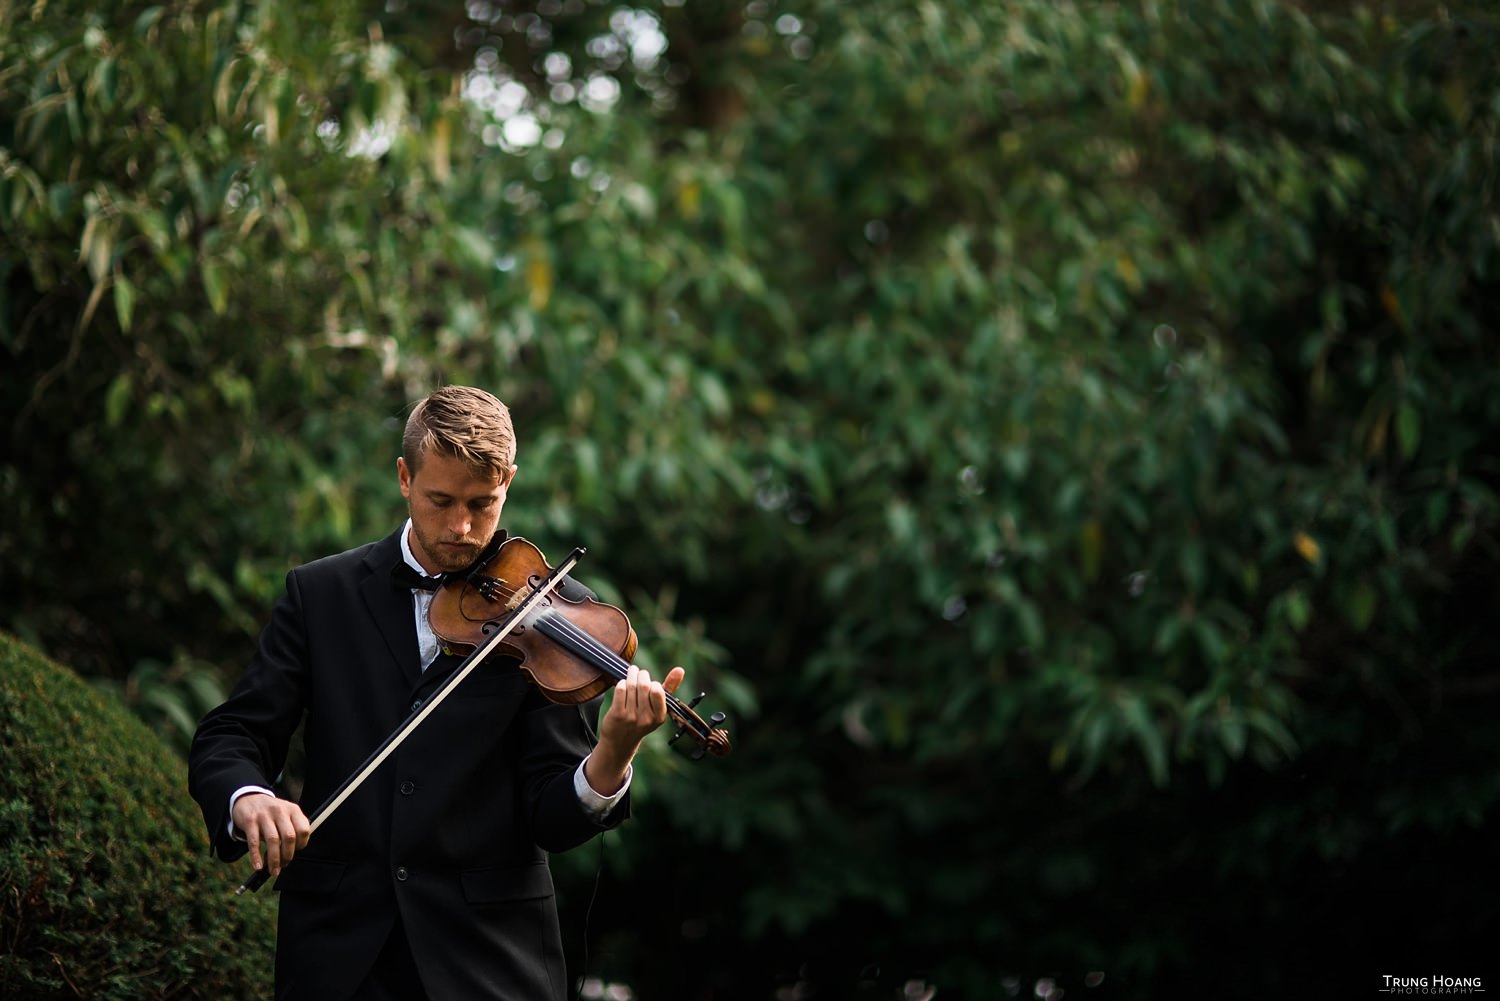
xmin=396 ymin=455 xmax=516 ymax=575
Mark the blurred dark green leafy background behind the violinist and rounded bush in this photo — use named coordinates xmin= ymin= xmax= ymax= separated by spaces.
xmin=0 ymin=0 xmax=1500 ymax=1001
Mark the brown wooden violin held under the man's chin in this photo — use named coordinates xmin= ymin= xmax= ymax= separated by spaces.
xmin=428 ymin=536 xmax=729 ymax=758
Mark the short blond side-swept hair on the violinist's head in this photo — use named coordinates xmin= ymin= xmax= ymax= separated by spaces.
xmin=401 ymin=386 xmax=516 ymax=477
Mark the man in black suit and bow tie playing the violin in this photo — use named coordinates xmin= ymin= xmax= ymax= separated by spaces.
xmin=189 ymin=386 xmax=683 ymax=1001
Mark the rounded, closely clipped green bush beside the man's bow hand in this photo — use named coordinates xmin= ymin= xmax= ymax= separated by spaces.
xmin=0 ymin=635 xmax=275 ymax=1001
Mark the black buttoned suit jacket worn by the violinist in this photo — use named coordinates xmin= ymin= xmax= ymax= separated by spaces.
xmin=189 ymin=530 xmax=629 ymax=1001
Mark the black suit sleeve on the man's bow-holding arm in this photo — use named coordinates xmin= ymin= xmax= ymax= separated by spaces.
xmin=188 ymin=570 xmax=308 ymax=861
